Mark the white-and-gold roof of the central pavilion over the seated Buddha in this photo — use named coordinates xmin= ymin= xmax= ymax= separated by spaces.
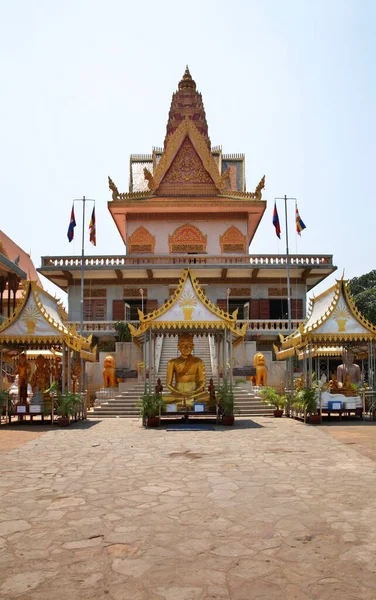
xmin=129 ymin=269 xmax=247 ymax=342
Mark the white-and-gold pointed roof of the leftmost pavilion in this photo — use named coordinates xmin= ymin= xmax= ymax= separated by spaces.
xmin=0 ymin=281 xmax=91 ymax=352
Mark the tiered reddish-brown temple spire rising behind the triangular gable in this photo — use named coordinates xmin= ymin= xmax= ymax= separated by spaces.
xmin=164 ymin=65 xmax=211 ymax=149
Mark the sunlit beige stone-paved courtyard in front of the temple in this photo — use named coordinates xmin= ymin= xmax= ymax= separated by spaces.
xmin=0 ymin=418 xmax=376 ymax=600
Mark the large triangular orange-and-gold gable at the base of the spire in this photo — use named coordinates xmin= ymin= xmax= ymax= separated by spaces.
xmin=144 ymin=117 xmax=228 ymax=194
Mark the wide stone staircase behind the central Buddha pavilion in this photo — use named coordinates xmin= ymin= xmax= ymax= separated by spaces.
xmin=88 ymin=336 xmax=273 ymax=418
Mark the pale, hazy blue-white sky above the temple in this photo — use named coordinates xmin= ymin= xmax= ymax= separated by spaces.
xmin=0 ymin=0 xmax=376 ymax=296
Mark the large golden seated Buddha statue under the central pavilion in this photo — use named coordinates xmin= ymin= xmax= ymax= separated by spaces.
xmin=163 ymin=333 xmax=210 ymax=410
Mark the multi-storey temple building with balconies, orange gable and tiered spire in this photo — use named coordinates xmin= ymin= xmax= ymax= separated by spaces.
xmin=39 ymin=68 xmax=336 ymax=350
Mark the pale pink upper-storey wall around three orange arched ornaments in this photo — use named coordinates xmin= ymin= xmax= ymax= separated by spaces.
xmin=127 ymin=219 xmax=247 ymax=255
